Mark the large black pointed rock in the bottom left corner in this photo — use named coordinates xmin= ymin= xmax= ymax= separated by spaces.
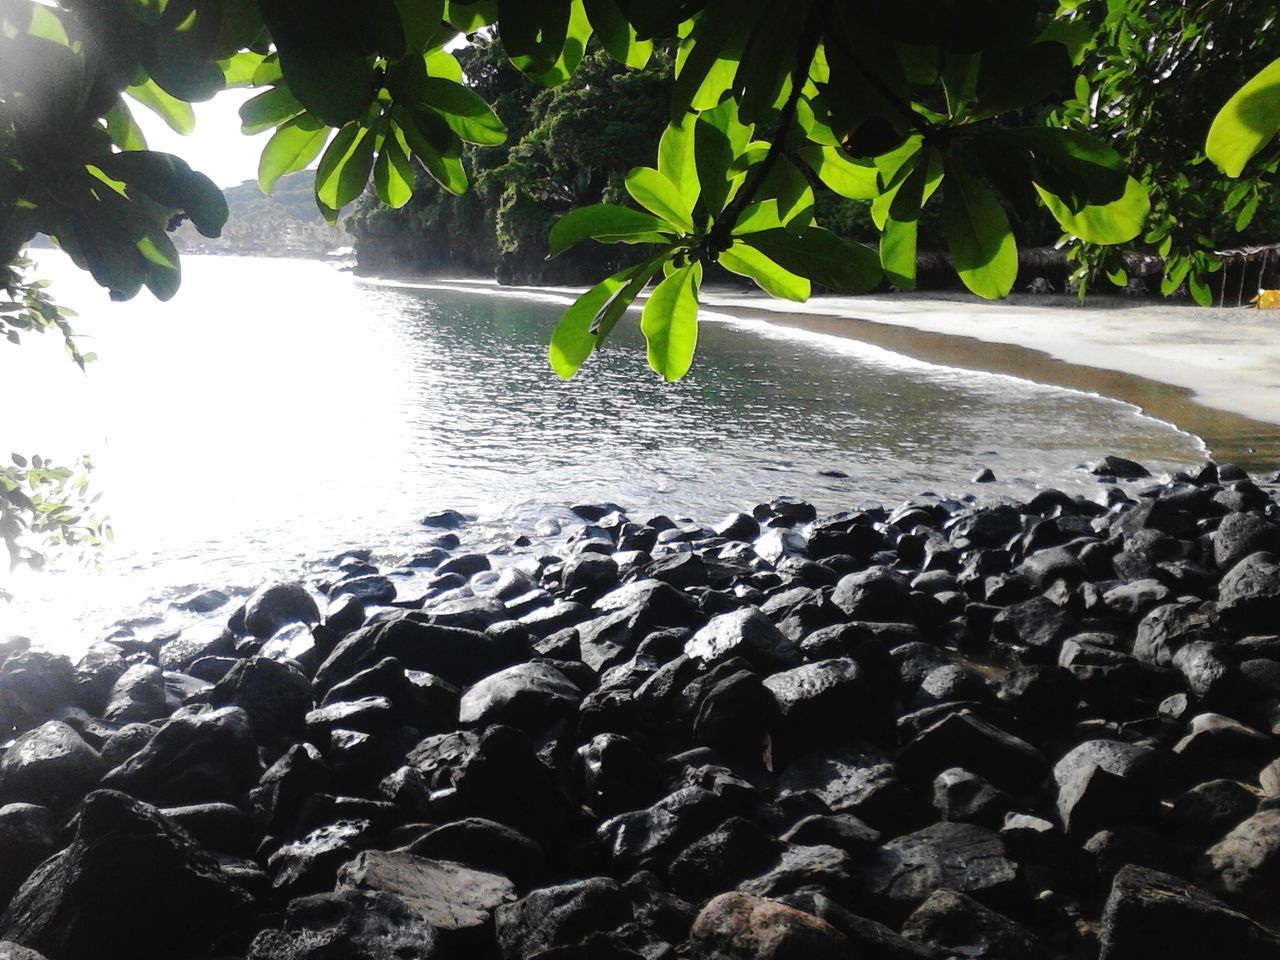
xmin=0 ymin=790 xmax=250 ymax=960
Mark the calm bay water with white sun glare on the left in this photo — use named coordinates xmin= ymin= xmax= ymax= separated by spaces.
xmin=0 ymin=253 xmax=1202 ymax=648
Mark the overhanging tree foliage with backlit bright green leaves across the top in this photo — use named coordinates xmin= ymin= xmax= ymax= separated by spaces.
xmin=0 ymin=0 xmax=1275 ymax=379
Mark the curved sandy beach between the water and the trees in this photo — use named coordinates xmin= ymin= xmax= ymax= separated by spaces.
xmin=362 ymin=276 xmax=1280 ymax=471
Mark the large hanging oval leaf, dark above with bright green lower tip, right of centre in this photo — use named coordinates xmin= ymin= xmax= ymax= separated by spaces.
xmin=942 ymin=164 xmax=1018 ymax=300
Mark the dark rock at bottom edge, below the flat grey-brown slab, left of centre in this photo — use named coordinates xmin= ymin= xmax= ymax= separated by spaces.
xmin=248 ymin=890 xmax=439 ymax=960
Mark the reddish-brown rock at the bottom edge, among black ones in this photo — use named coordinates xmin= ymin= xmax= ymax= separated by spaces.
xmin=690 ymin=892 xmax=854 ymax=960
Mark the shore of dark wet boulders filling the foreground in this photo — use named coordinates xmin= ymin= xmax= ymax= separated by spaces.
xmin=0 ymin=458 xmax=1280 ymax=960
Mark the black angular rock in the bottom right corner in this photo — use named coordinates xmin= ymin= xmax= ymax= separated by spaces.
xmin=1098 ymin=864 xmax=1280 ymax=960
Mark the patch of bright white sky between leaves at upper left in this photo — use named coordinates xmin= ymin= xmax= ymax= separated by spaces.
xmin=129 ymin=90 xmax=271 ymax=187
